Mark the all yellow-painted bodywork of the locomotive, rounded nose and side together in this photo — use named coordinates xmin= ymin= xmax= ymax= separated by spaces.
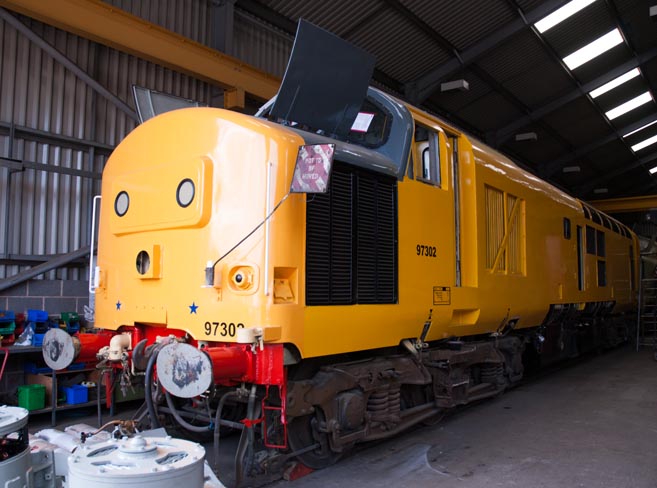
xmin=96 ymin=103 xmax=636 ymax=357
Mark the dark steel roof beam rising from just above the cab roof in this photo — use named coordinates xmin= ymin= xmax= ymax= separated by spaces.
xmin=406 ymin=0 xmax=568 ymax=104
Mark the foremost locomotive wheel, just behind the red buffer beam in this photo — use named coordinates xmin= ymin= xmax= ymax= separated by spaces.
xmin=287 ymin=409 xmax=342 ymax=469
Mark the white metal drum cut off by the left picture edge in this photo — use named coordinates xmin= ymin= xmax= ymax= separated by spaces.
xmin=0 ymin=406 xmax=30 ymax=488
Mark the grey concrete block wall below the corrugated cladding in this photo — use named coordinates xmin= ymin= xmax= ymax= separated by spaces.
xmin=0 ymin=280 xmax=89 ymax=316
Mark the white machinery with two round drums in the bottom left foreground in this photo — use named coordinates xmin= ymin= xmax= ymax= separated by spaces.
xmin=0 ymin=406 xmax=223 ymax=488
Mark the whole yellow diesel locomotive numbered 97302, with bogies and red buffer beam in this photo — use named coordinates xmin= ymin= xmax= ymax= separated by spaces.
xmin=50 ymin=20 xmax=638 ymax=479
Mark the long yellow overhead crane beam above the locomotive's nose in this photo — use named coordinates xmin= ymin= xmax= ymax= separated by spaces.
xmin=0 ymin=0 xmax=280 ymax=100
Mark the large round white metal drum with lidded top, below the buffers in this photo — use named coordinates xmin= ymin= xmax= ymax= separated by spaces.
xmin=67 ymin=436 xmax=205 ymax=488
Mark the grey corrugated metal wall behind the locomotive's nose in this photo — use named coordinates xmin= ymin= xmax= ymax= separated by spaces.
xmin=0 ymin=8 xmax=217 ymax=279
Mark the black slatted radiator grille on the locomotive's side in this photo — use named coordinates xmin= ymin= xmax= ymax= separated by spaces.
xmin=306 ymin=163 xmax=397 ymax=305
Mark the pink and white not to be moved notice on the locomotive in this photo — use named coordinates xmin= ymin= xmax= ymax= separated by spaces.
xmin=290 ymin=144 xmax=335 ymax=193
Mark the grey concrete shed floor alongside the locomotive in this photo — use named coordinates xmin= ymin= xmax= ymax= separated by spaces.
xmin=25 ymin=347 xmax=657 ymax=488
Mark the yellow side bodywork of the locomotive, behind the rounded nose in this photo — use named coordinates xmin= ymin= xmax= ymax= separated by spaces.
xmin=302 ymin=107 xmax=638 ymax=357
